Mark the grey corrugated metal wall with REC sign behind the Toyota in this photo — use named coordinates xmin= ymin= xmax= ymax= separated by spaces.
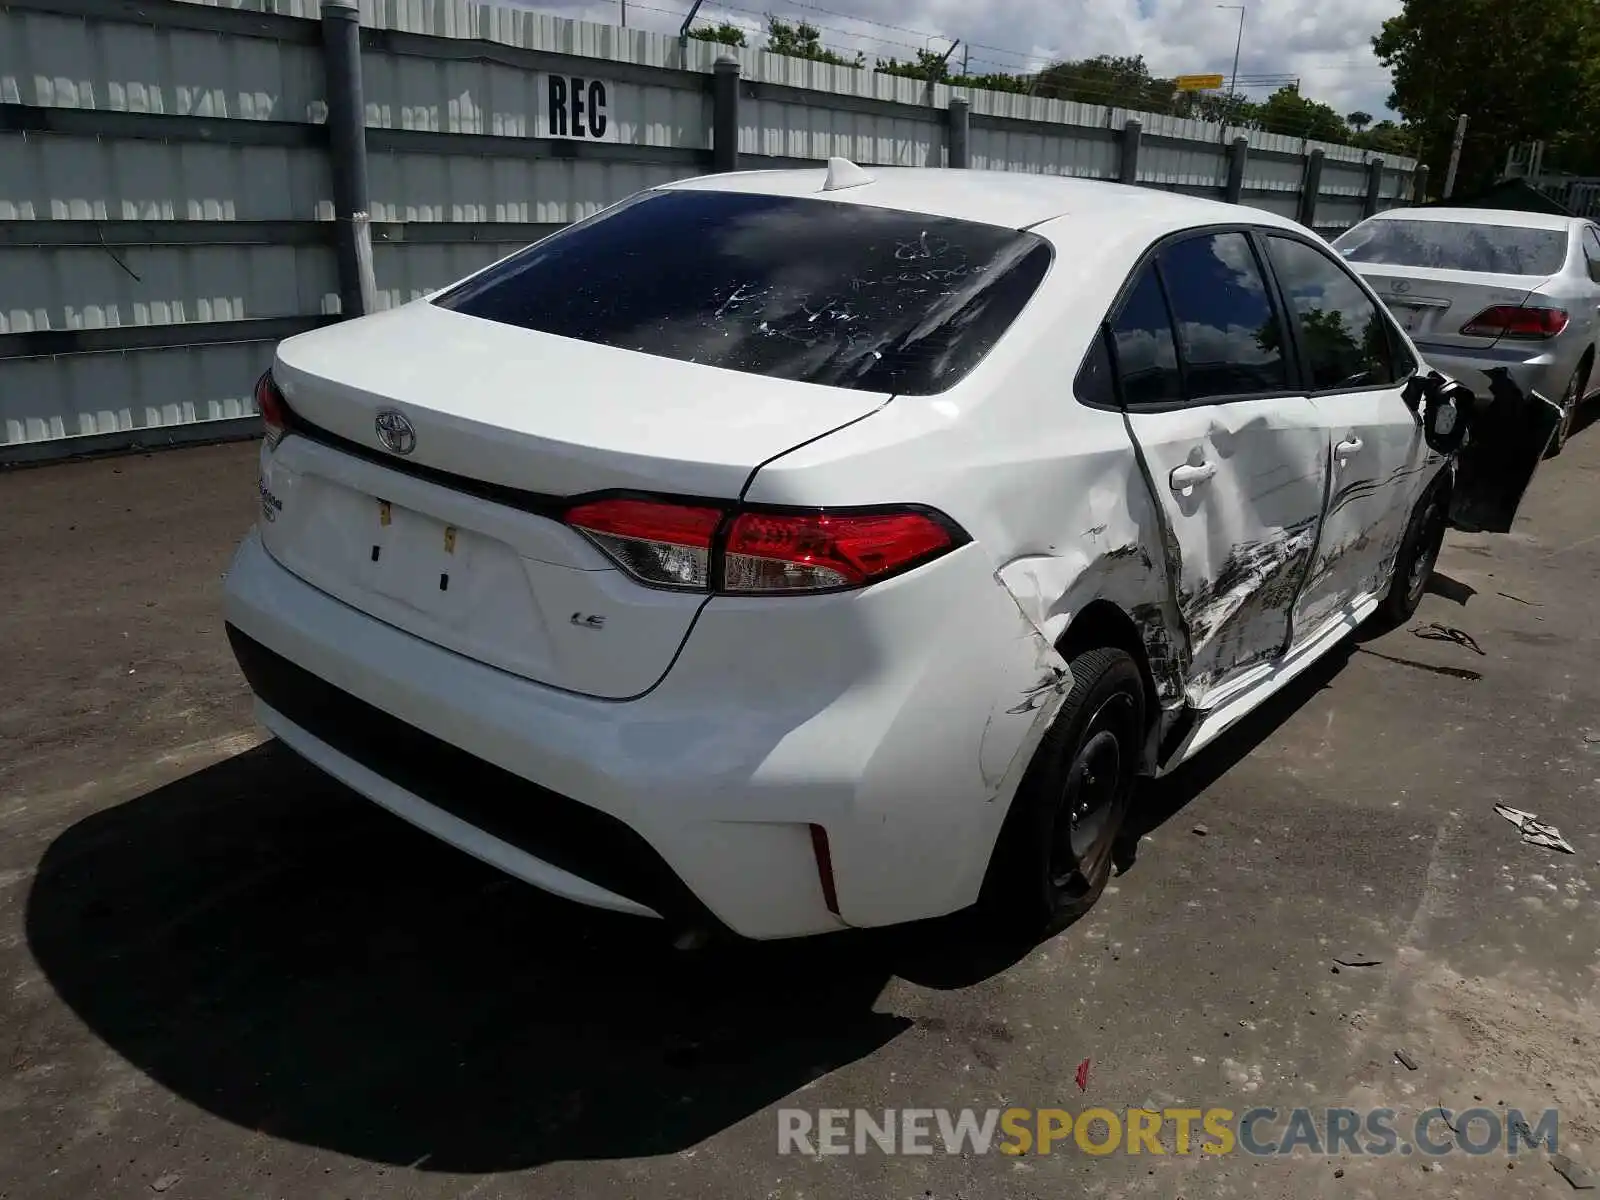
xmin=0 ymin=0 xmax=1414 ymax=462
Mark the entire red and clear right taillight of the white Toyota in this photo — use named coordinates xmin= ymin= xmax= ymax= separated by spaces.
xmin=566 ymin=499 xmax=966 ymax=595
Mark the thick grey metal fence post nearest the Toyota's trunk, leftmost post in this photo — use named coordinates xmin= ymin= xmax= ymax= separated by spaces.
xmin=322 ymin=0 xmax=378 ymax=317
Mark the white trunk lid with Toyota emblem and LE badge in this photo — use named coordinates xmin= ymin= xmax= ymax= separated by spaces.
xmin=261 ymin=301 xmax=888 ymax=699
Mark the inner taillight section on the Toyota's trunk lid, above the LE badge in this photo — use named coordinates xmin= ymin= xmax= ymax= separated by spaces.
xmin=566 ymin=499 xmax=723 ymax=592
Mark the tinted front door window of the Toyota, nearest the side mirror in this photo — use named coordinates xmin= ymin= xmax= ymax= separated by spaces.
xmin=1267 ymin=237 xmax=1395 ymax=392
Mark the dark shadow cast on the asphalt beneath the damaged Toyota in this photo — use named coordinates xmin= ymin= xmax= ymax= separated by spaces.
xmin=27 ymin=643 xmax=1376 ymax=1173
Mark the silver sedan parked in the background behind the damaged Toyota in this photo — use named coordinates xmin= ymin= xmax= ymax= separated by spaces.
xmin=1333 ymin=208 xmax=1600 ymax=453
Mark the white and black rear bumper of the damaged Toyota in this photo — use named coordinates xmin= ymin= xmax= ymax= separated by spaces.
xmin=224 ymin=534 xmax=1037 ymax=938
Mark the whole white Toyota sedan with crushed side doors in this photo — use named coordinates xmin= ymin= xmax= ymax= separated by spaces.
xmin=226 ymin=160 xmax=1558 ymax=938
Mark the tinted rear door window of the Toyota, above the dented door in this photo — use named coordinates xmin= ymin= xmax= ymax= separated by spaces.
xmin=1157 ymin=232 xmax=1288 ymax=400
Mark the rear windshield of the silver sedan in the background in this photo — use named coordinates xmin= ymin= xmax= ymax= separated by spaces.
xmin=1333 ymin=219 xmax=1566 ymax=275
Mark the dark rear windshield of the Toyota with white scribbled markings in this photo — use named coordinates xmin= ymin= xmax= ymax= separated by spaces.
xmin=434 ymin=190 xmax=1050 ymax=395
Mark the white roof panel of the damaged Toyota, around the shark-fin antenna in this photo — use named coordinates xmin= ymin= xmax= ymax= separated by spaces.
xmin=662 ymin=166 xmax=1301 ymax=232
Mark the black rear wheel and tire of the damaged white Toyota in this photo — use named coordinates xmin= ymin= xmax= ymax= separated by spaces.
xmin=982 ymin=646 xmax=1146 ymax=941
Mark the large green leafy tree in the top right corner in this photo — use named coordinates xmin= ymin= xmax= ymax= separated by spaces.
xmin=1373 ymin=0 xmax=1600 ymax=190
